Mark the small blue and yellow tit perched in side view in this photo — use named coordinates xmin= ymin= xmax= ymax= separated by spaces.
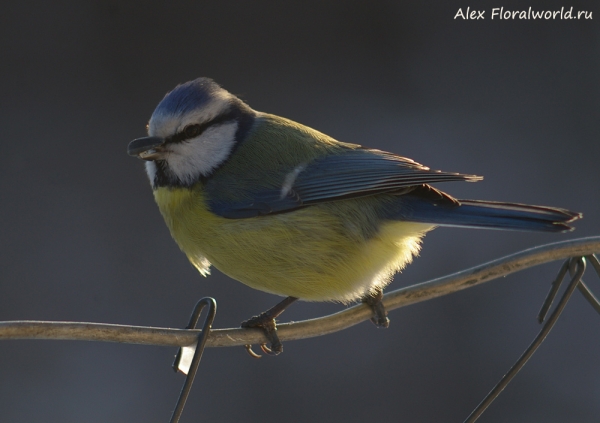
xmin=127 ymin=77 xmax=582 ymax=355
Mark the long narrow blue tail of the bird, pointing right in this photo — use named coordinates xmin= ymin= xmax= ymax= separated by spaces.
xmin=396 ymin=190 xmax=582 ymax=232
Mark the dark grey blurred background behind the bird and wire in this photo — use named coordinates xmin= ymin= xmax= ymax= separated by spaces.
xmin=0 ymin=0 xmax=600 ymax=423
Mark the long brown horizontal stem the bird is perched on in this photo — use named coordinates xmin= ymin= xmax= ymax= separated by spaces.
xmin=0 ymin=236 xmax=600 ymax=347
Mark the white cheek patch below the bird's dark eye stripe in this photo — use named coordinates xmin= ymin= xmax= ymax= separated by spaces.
xmin=166 ymin=122 xmax=238 ymax=183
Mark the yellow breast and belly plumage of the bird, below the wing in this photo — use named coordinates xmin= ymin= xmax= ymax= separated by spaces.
xmin=154 ymin=188 xmax=433 ymax=302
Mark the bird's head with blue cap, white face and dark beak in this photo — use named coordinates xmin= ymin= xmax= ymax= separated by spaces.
xmin=127 ymin=78 xmax=255 ymax=187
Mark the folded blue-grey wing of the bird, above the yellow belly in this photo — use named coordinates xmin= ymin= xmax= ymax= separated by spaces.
xmin=205 ymin=148 xmax=482 ymax=219
